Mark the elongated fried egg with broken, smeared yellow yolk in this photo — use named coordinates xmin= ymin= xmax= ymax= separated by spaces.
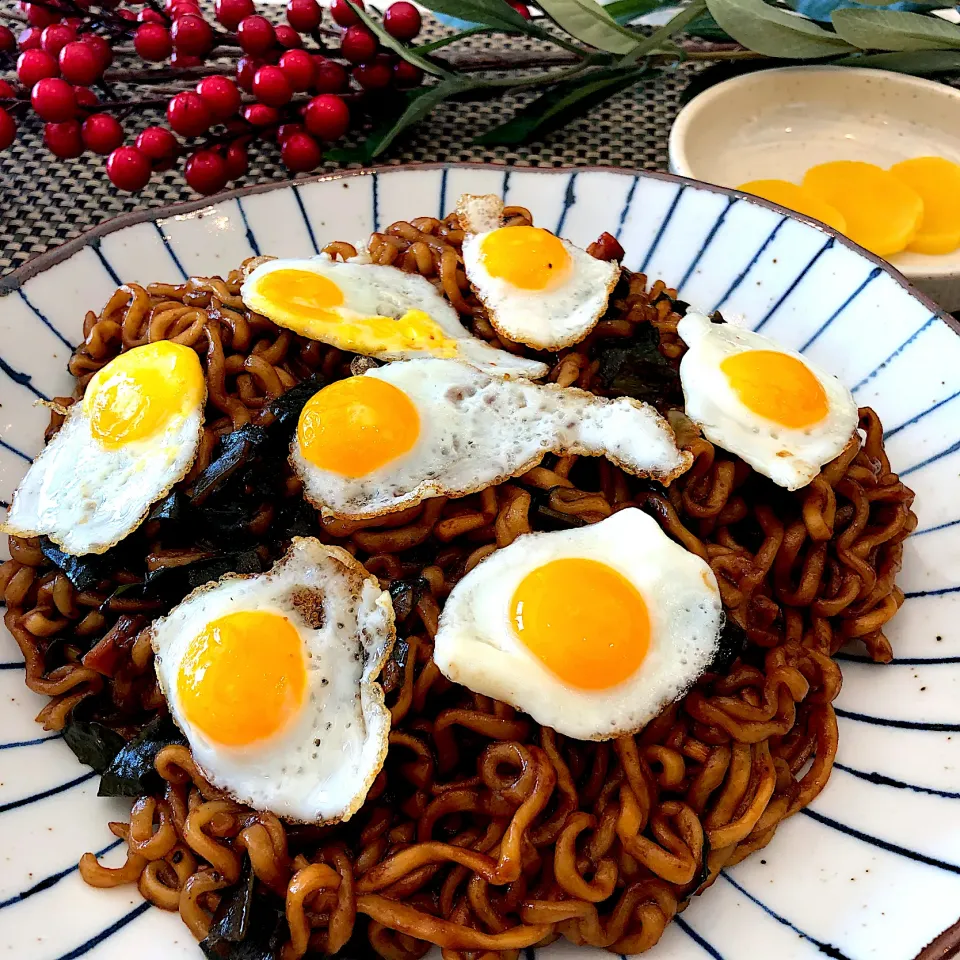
xmin=240 ymin=256 xmax=548 ymax=379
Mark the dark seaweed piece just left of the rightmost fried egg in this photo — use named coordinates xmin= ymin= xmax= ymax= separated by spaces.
xmin=594 ymin=323 xmax=682 ymax=406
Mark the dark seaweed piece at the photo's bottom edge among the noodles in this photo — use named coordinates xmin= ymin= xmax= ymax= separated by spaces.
xmin=200 ymin=857 xmax=289 ymax=960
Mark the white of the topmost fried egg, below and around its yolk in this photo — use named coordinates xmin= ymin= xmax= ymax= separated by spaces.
xmin=462 ymin=233 xmax=620 ymax=351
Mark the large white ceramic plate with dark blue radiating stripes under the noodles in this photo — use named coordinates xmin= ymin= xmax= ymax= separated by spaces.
xmin=0 ymin=166 xmax=960 ymax=960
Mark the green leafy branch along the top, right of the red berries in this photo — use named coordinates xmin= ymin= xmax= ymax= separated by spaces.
xmin=342 ymin=0 xmax=960 ymax=163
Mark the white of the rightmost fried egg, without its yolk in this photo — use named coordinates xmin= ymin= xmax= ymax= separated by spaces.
xmin=677 ymin=312 xmax=859 ymax=490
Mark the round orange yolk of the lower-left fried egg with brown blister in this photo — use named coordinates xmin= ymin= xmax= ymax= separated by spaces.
xmin=177 ymin=610 xmax=307 ymax=747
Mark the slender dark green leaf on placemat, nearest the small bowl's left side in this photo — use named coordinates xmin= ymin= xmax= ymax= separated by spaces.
xmin=473 ymin=67 xmax=655 ymax=146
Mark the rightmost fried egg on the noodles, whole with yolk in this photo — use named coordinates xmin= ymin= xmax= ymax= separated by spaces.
xmin=677 ymin=312 xmax=858 ymax=490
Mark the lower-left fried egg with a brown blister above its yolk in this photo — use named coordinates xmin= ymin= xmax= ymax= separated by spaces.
xmin=150 ymin=538 xmax=396 ymax=823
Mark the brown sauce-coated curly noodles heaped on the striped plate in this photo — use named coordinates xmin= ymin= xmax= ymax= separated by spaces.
xmin=0 ymin=207 xmax=916 ymax=960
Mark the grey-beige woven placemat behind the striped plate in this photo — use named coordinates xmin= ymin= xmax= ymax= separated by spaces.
xmin=0 ymin=7 xmax=696 ymax=276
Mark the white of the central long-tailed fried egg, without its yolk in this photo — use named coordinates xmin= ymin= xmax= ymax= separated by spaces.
xmin=290 ymin=359 xmax=693 ymax=520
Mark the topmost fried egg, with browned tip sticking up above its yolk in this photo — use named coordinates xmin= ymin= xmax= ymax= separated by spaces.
xmin=457 ymin=194 xmax=620 ymax=350
